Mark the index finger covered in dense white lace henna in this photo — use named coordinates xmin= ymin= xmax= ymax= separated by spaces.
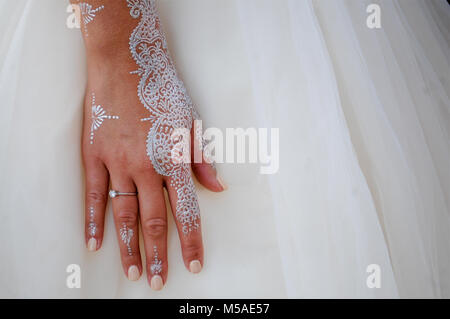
xmin=165 ymin=169 xmax=203 ymax=273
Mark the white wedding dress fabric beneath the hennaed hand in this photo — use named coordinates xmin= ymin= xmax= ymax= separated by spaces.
xmin=0 ymin=0 xmax=450 ymax=298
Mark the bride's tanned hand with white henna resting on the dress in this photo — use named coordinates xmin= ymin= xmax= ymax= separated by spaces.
xmin=78 ymin=0 xmax=229 ymax=290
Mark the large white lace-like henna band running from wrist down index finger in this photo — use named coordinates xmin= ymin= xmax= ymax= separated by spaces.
xmin=127 ymin=0 xmax=200 ymax=234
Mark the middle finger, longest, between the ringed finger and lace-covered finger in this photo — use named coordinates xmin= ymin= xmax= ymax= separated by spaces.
xmin=136 ymin=174 xmax=168 ymax=290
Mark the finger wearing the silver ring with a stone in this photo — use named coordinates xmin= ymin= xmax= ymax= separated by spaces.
xmin=111 ymin=172 xmax=142 ymax=281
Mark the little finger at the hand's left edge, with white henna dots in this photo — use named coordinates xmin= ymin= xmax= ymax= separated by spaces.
xmin=84 ymin=160 xmax=109 ymax=251
